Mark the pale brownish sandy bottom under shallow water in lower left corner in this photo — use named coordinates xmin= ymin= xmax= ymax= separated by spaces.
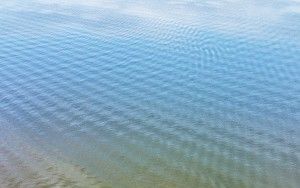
xmin=0 ymin=119 xmax=109 ymax=188
